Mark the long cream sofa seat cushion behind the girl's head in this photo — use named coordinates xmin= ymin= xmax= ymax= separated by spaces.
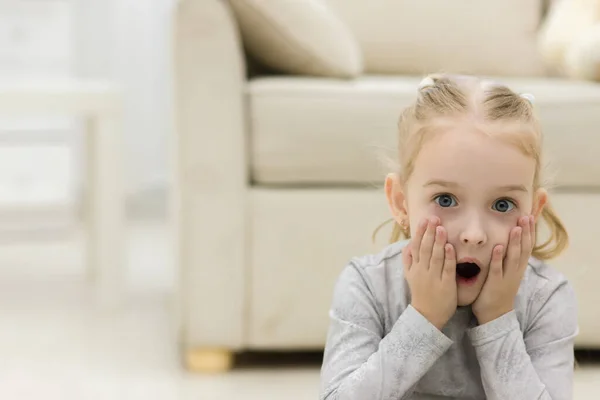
xmin=247 ymin=76 xmax=600 ymax=187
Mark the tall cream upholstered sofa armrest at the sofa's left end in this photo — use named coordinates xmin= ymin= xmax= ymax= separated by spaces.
xmin=170 ymin=0 xmax=248 ymax=349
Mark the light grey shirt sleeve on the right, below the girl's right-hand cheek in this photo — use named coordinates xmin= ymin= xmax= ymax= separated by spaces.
xmin=469 ymin=281 xmax=579 ymax=400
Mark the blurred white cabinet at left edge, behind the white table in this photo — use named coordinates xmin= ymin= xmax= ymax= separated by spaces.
xmin=0 ymin=0 xmax=76 ymax=225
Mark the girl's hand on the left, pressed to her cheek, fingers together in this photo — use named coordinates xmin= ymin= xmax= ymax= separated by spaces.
xmin=402 ymin=217 xmax=457 ymax=330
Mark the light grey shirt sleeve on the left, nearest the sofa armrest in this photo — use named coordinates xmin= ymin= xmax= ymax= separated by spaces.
xmin=320 ymin=264 xmax=452 ymax=400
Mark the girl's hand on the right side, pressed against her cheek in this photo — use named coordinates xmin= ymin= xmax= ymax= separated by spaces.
xmin=473 ymin=216 xmax=535 ymax=324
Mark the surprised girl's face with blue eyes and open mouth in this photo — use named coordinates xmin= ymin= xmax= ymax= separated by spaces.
xmin=392 ymin=124 xmax=546 ymax=306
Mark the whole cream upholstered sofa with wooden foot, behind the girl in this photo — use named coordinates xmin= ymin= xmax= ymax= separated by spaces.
xmin=172 ymin=0 xmax=600 ymax=370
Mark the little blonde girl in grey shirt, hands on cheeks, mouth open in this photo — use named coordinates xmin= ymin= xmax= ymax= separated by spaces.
xmin=320 ymin=75 xmax=578 ymax=400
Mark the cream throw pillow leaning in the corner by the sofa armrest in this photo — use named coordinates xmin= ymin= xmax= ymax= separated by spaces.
xmin=229 ymin=0 xmax=363 ymax=78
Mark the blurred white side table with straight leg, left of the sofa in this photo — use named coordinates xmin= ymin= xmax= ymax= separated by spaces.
xmin=0 ymin=80 xmax=125 ymax=307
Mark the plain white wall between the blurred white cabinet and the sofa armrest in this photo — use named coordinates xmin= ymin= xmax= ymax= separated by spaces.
xmin=72 ymin=0 xmax=174 ymax=206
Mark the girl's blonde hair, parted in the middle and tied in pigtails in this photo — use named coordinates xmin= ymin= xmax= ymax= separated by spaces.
xmin=373 ymin=74 xmax=569 ymax=261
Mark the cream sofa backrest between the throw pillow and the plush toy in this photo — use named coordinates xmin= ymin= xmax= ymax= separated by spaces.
xmin=325 ymin=0 xmax=547 ymax=76
